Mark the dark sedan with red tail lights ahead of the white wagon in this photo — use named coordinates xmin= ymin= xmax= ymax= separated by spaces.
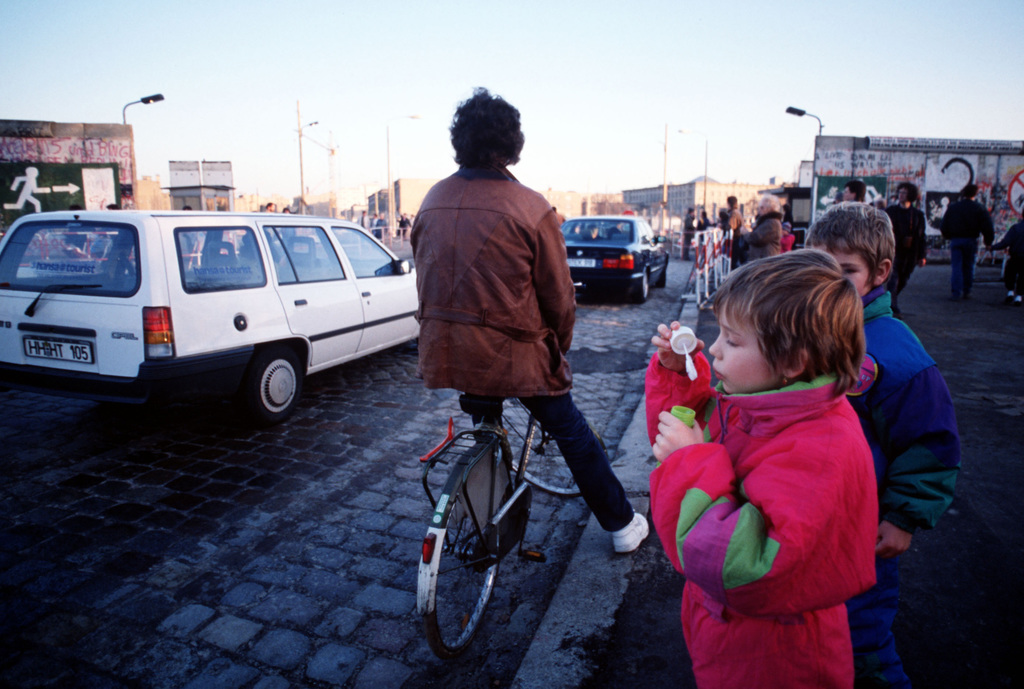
xmin=562 ymin=215 xmax=669 ymax=304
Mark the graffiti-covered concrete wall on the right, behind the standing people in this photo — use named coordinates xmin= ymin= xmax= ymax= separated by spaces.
xmin=813 ymin=136 xmax=1024 ymax=258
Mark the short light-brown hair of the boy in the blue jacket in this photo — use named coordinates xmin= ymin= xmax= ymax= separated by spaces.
xmin=806 ymin=202 xmax=896 ymax=275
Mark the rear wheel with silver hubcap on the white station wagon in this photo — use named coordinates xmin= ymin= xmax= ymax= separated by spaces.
xmin=239 ymin=345 xmax=305 ymax=426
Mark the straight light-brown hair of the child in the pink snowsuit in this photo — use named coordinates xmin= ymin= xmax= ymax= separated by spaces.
xmin=715 ymin=249 xmax=864 ymax=394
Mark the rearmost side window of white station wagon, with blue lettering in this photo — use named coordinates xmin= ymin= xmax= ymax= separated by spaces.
xmin=174 ymin=227 xmax=266 ymax=294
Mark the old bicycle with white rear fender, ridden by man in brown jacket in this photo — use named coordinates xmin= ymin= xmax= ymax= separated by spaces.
xmin=416 ymin=394 xmax=581 ymax=658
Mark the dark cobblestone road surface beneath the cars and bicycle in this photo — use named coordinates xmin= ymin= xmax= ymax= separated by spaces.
xmin=0 ymin=254 xmax=689 ymax=689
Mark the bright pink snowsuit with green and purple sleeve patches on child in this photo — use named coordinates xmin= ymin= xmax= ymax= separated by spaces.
xmin=646 ymin=354 xmax=878 ymax=689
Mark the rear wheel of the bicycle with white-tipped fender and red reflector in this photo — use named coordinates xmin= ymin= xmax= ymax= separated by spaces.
xmin=417 ymin=440 xmax=510 ymax=658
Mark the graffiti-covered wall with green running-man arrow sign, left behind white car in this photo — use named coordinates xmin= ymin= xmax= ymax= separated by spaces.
xmin=0 ymin=120 xmax=134 ymax=225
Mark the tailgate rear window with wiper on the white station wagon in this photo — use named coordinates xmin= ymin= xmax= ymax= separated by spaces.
xmin=0 ymin=220 xmax=139 ymax=297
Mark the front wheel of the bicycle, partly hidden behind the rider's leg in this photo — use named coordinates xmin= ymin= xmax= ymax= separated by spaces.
xmin=502 ymin=399 xmax=581 ymax=498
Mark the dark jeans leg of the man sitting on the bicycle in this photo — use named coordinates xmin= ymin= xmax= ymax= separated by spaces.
xmin=519 ymin=393 xmax=633 ymax=531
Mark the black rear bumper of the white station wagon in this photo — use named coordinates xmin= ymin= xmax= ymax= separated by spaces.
xmin=0 ymin=347 xmax=254 ymax=404
